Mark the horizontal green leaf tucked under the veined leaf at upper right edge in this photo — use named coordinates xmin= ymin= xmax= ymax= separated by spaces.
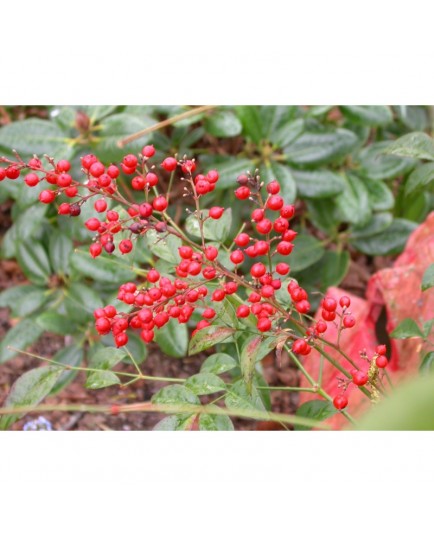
xmin=357 ymin=141 xmax=416 ymax=181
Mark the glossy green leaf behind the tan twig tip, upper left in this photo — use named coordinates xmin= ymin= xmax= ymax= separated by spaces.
xmin=96 ymin=113 xmax=155 ymax=163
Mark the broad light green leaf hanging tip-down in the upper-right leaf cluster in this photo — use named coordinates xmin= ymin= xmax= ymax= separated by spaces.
xmin=336 ymin=173 xmax=371 ymax=225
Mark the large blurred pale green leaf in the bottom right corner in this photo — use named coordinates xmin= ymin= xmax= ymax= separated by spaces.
xmin=357 ymin=374 xmax=434 ymax=432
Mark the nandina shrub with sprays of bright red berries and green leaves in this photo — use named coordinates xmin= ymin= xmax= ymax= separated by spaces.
xmin=0 ymin=145 xmax=387 ymax=430
